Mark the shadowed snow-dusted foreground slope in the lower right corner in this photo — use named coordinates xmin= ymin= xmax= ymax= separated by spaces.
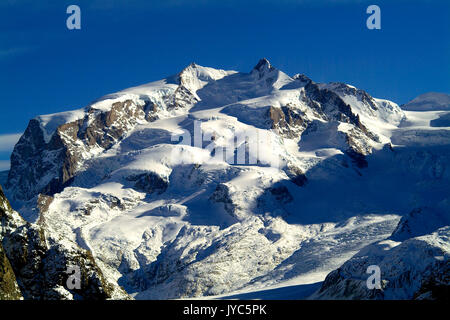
xmin=310 ymin=216 xmax=450 ymax=301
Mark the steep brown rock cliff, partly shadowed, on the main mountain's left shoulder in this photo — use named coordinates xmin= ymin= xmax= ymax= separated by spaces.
xmin=6 ymin=100 xmax=149 ymax=200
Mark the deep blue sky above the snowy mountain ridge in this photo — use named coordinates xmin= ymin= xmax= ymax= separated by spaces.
xmin=0 ymin=0 xmax=450 ymax=169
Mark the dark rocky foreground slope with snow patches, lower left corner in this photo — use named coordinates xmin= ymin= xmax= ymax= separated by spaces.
xmin=0 ymin=188 xmax=126 ymax=300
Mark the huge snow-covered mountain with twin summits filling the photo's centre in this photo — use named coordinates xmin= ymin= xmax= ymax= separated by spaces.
xmin=0 ymin=59 xmax=450 ymax=299
